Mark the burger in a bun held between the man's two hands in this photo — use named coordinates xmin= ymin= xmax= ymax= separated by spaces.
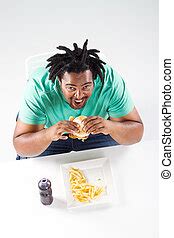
xmin=69 ymin=116 xmax=89 ymax=141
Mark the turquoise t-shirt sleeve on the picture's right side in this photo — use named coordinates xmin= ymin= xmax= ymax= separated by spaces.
xmin=108 ymin=68 xmax=134 ymax=118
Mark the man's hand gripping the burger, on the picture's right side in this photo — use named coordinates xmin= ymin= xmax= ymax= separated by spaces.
xmin=83 ymin=116 xmax=109 ymax=135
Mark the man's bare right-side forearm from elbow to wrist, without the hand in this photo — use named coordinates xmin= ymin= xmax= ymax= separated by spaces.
xmin=109 ymin=120 xmax=144 ymax=145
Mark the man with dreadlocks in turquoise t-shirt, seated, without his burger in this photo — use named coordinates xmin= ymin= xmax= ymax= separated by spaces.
xmin=13 ymin=40 xmax=143 ymax=157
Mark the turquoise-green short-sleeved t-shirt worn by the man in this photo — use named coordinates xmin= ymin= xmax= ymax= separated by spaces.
xmin=19 ymin=62 xmax=134 ymax=128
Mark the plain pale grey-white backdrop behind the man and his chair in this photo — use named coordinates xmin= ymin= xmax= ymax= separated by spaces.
xmin=0 ymin=0 xmax=158 ymax=161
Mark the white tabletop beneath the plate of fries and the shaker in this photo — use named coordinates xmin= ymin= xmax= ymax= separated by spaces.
xmin=0 ymin=141 xmax=158 ymax=238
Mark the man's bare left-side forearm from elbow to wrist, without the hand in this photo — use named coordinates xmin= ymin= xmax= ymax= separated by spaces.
xmin=13 ymin=129 xmax=52 ymax=157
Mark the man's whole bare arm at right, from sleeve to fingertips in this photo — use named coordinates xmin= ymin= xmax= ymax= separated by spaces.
xmin=84 ymin=108 xmax=144 ymax=145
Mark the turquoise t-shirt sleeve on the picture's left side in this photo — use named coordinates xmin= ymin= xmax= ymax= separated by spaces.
xmin=19 ymin=79 xmax=46 ymax=125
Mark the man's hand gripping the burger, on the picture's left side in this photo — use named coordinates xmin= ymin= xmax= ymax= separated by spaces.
xmin=47 ymin=121 xmax=79 ymax=141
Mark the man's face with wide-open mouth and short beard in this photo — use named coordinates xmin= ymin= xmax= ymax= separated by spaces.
xmin=60 ymin=70 xmax=94 ymax=109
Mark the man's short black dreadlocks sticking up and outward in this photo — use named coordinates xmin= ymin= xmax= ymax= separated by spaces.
xmin=46 ymin=40 xmax=106 ymax=84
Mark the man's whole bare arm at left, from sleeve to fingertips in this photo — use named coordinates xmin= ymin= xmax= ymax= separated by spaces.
xmin=13 ymin=120 xmax=78 ymax=157
